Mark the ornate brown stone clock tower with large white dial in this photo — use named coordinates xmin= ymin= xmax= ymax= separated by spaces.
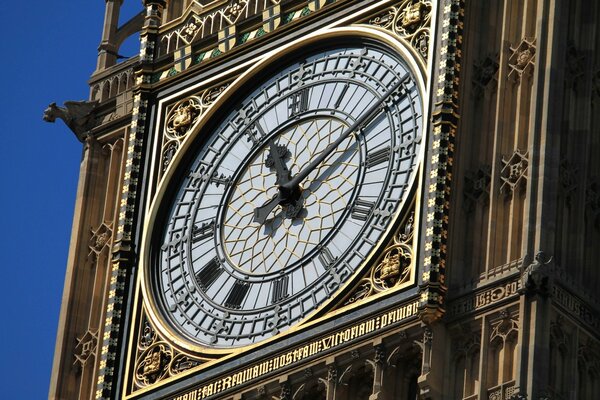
xmin=44 ymin=0 xmax=600 ymax=400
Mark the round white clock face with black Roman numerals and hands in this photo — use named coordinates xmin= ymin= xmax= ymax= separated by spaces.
xmin=150 ymin=39 xmax=422 ymax=349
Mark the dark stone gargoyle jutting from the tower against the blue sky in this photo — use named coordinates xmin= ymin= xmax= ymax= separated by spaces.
xmin=44 ymin=101 xmax=98 ymax=143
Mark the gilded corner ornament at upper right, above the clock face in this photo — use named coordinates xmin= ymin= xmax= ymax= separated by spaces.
xmin=368 ymin=0 xmax=431 ymax=59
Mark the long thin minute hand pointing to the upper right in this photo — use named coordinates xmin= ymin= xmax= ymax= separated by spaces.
xmin=280 ymin=74 xmax=410 ymax=194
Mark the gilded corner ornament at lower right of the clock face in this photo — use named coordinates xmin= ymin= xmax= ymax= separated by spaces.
xmin=343 ymin=213 xmax=414 ymax=305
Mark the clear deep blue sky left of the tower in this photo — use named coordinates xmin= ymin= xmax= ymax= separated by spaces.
xmin=0 ymin=0 xmax=142 ymax=399
